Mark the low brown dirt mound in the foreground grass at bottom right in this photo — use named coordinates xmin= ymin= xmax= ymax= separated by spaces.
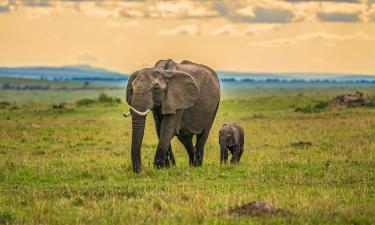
xmin=228 ymin=201 xmax=291 ymax=217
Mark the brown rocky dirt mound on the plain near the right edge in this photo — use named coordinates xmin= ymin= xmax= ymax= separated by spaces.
xmin=329 ymin=91 xmax=371 ymax=107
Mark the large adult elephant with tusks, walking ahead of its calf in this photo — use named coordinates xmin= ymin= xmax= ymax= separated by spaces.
xmin=126 ymin=59 xmax=220 ymax=172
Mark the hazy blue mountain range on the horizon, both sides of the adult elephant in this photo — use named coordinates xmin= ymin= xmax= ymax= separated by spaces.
xmin=0 ymin=65 xmax=375 ymax=85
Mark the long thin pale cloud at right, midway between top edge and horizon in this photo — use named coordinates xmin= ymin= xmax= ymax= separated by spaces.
xmin=249 ymin=31 xmax=375 ymax=47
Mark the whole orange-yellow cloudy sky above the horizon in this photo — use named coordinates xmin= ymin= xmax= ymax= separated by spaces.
xmin=0 ymin=0 xmax=375 ymax=75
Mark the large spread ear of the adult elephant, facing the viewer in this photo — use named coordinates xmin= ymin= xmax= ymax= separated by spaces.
xmin=161 ymin=70 xmax=199 ymax=114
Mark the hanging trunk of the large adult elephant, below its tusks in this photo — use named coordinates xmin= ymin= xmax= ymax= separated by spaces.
xmin=131 ymin=115 xmax=146 ymax=173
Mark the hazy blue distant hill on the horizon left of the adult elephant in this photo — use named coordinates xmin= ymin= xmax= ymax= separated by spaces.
xmin=0 ymin=65 xmax=128 ymax=81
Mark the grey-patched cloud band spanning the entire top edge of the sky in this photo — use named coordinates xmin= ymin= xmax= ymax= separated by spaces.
xmin=0 ymin=0 xmax=375 ymax=23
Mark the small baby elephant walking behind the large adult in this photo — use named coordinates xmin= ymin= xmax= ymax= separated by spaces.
xmin=219 ymin=122 xmax=244 ymax=163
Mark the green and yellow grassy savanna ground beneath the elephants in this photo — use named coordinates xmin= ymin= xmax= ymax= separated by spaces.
xmin=0 ymin=78 xmax=375 ymax=224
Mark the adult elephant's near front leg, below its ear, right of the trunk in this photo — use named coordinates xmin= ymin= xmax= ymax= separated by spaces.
xmin=154 ymin=114 xmax=177 ymax=168
